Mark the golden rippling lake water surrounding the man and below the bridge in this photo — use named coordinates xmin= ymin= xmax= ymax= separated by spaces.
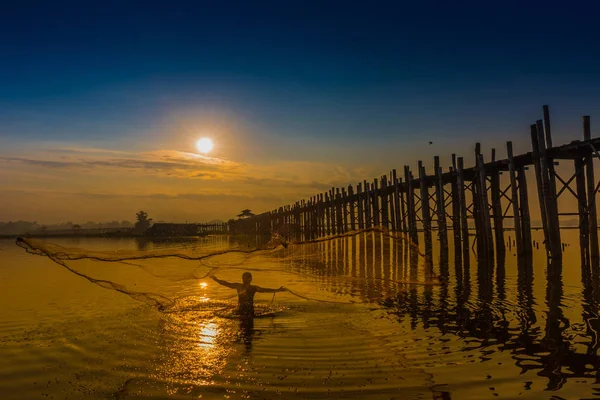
xmin=0 ymin=230 xmax=600 ymax=399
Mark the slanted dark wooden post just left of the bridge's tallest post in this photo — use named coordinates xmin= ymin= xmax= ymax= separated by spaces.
xmin=536 ymin=121 xmax=562 ymax=260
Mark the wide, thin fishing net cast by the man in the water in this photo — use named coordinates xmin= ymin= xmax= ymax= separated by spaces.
xmin=16 ymin=229 xmax=439 ymax=317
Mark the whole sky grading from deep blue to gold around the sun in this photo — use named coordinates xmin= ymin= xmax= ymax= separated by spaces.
xmin=0 ymin=0 xmax=600 ymax=223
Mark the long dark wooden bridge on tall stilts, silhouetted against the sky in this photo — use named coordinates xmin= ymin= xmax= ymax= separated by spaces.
xmin=230 ymin=106 xmax=600 ymax=265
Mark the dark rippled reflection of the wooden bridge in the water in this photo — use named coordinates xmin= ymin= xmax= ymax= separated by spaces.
xmin=274 ymin=231 xmax=600 ymax=398
